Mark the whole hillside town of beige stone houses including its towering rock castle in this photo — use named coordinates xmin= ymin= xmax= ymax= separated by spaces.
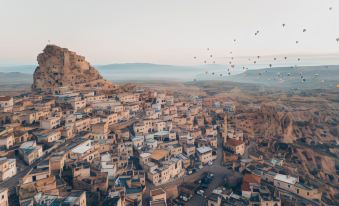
xmin=0 ymin=45 xmax=335 ymax=206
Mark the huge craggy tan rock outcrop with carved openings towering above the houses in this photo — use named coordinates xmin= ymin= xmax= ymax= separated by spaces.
xmin=32 ymin=45 xmax=117 ymax=93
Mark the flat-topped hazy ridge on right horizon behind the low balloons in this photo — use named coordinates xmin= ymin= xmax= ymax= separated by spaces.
xmin=225 ymin=66 xmax=339 ymax=89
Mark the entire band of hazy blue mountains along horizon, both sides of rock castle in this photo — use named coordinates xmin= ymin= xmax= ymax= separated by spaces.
xmin=0 ymin=63 xmax=339 ymax=88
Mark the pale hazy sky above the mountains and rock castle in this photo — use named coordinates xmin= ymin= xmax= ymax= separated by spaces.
xmin=0 ymin=0 xmax=339 ymax=65
